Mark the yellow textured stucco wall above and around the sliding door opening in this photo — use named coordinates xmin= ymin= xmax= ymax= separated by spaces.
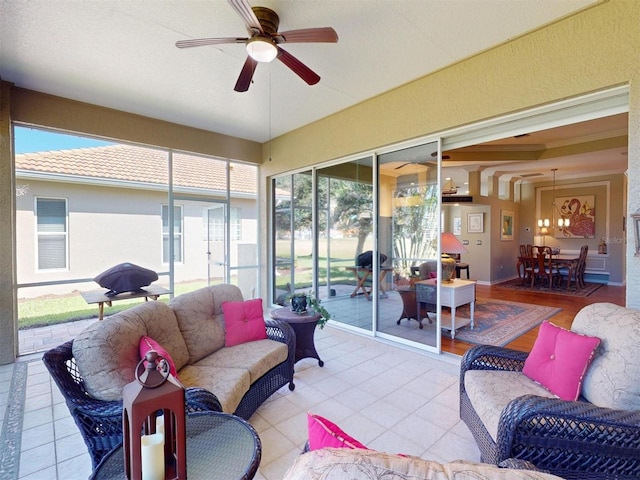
xmin=260 ymin=0 xmax=640 ymax=307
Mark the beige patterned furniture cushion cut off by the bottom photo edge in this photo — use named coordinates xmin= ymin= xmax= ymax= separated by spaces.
xmin=284 ymin=448 xmax=560 ymax=480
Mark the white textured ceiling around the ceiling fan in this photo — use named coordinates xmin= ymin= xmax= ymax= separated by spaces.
xmin=0 ymin=0 xmax=597 ymax=142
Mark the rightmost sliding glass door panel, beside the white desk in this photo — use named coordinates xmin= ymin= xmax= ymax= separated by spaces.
xmin=377 ymin=142 xmax=440 ymax=348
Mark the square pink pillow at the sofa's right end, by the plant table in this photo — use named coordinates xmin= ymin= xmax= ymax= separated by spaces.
xmin=222 ymin=298 xmax=268 ymax=347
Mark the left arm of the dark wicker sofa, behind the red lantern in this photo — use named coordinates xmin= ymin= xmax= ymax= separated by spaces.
xmin=42 ymin=340 xmax=222 ymax=469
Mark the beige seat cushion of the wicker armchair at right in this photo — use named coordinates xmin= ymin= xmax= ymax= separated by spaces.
xmin=464 ymin=370 xmax=555 ymax=442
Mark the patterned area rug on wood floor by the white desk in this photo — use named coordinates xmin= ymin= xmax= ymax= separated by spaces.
xmin=442 ymin=298 xmax=562 ymax=347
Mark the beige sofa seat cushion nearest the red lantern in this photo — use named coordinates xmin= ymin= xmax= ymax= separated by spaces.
xmin=178 ymin=365 xmax=251 ymax=413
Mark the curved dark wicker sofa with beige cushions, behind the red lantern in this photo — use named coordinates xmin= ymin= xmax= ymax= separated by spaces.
xmin=43 ymin=285 xmax=295 ymax=467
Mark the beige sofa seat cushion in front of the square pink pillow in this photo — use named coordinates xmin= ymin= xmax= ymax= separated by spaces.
xmin=194 ymin=340 xmax=289 ymax=383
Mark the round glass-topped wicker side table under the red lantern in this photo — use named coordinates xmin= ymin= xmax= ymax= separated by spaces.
xmin=90 ymin=412 xmax=262 ymax=480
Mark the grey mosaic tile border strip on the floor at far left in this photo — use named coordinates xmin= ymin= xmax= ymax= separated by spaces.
xmin=0 ymin=362 xmax=28 ymax=480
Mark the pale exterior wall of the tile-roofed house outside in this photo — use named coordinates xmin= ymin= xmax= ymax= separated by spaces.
xmin=16 ymin=179 xmax=257 ymax=298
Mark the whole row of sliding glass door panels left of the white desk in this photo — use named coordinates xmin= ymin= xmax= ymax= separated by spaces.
xmin=271 ymin=141 xmax=440 ymax=350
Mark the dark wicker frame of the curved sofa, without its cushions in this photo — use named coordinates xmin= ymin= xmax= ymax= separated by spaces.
xmin=42 ymin=320 xmax=295 ymax=469
